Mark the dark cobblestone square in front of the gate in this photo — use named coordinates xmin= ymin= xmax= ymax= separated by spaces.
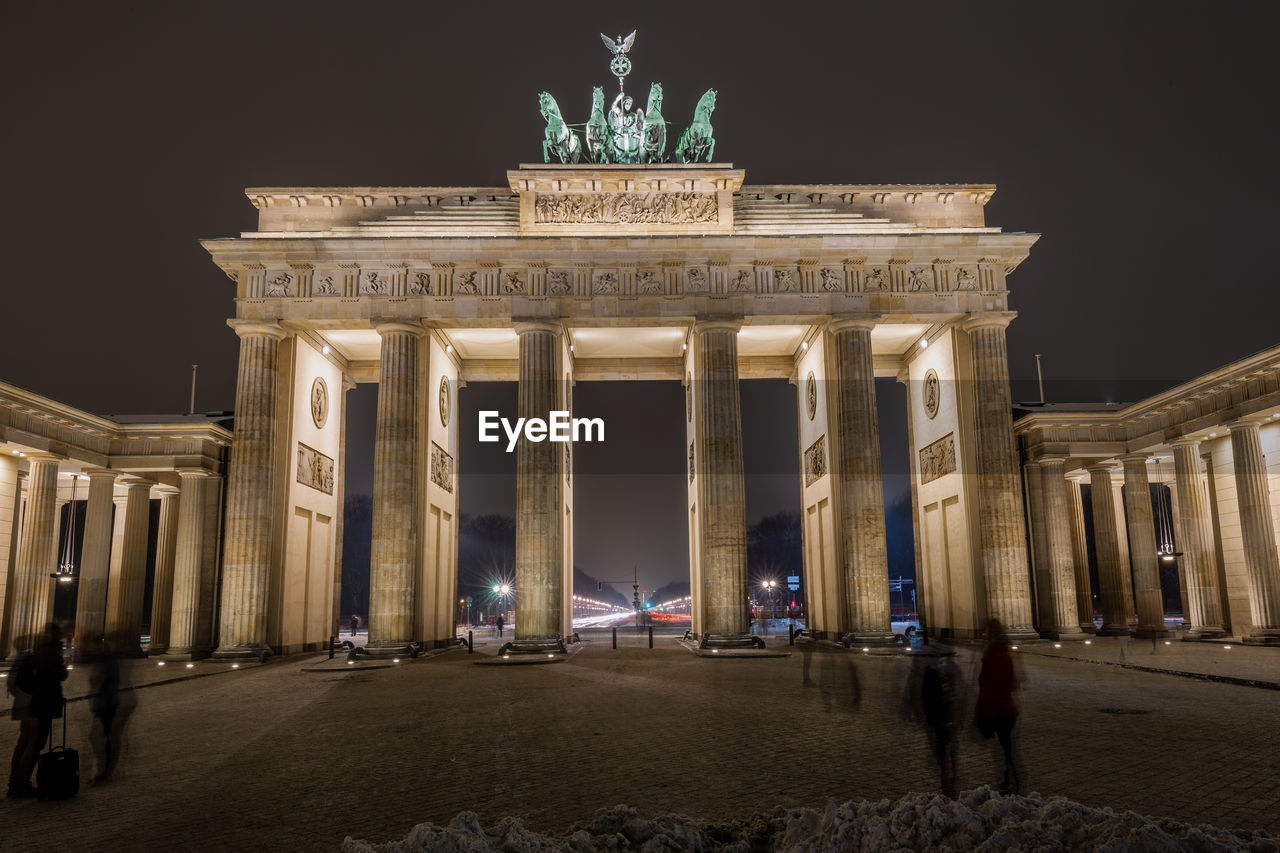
xmin=0 ymin=637 xmax=1280 ymax=850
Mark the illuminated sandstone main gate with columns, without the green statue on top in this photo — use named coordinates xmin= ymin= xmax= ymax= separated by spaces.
xmin=204 ymin=159 xmax=1036 ymax=657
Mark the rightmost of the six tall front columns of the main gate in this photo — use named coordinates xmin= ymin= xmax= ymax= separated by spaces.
xmin=964 ymin=314 xmax=1037 ymax=639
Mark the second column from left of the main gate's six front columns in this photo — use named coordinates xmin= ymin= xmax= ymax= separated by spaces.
xmin=365 ymin=323 xmax=426 ymax=657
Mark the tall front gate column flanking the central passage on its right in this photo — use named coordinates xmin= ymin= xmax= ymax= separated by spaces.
xmin=694 ymin=320 xmax=751 ymax=648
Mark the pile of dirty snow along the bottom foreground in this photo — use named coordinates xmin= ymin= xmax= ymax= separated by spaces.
xmin=342 ymin=786 xmax=1280 ymax=853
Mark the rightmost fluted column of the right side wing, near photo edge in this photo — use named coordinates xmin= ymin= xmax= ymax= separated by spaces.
xmin=1226 ymin=421 xmax=1280 ymax=644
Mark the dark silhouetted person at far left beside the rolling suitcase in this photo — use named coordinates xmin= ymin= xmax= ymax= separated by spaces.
xmin=8 ymin=622 xmax=67 ymax=798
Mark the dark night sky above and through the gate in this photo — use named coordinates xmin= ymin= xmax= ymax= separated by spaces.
xmin=0 ymin=1 xmax=1280 ymax=591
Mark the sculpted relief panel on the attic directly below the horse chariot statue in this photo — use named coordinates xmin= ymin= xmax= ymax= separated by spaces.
xmin=534 ymin=192 xmax=719 ymax=225
